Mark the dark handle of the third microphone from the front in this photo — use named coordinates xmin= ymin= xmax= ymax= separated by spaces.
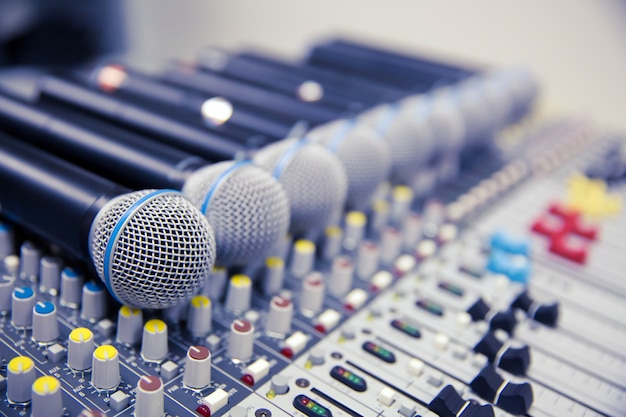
xmin=38 ymin=76 xmax=247 ymax=161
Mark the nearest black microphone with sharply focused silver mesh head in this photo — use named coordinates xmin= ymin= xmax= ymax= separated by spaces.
xmin=0 ymin=134 xmax=216 ymax=309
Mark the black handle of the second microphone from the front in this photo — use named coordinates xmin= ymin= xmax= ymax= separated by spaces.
xmin=0 ymin=96 xmax=208 ymax=190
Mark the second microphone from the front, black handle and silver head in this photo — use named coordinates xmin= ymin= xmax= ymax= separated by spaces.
xmin=0 ymin=96 xmax=289 ymax=266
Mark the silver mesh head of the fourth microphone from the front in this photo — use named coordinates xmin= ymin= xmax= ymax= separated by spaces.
xmin=307 ymin=120 xmax=391 ymax=208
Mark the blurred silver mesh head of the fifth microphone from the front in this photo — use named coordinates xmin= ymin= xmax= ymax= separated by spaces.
xmin=360 ymin=97 xmax=435 ymax=183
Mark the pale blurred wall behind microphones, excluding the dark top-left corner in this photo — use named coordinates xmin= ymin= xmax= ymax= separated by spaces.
xmin=123 ymin=0 xmax=626 ymax=132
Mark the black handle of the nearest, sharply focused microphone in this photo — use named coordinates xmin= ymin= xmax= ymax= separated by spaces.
xmin=0 ymin=133 xmax=129 ymax=259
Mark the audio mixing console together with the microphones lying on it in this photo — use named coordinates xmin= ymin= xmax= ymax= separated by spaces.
xmin=0 ymin=36 xmax=626 ymax=417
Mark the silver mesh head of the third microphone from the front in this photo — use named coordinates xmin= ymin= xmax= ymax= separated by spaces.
xmin=254 ymin=139 xmax=348 ymax=235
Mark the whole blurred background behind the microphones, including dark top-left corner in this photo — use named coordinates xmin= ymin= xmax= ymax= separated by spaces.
xmin=0 ymin=0 xmax=626 ymax=129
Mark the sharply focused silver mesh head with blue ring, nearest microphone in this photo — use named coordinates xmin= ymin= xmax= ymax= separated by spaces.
xmin=89 ymin=190 xmax=215 ymax=308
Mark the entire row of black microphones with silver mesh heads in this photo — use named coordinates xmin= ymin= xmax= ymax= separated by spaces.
xmin=0 ymin=40 xmax=537 ymax=308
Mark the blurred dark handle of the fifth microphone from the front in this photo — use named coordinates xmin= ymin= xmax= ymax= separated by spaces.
xmin=162 ymin=64 xmax=342 ymax=125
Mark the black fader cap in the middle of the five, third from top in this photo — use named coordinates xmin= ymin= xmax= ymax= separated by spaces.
xmin=474 ymin=331 xmax=530 ymax=375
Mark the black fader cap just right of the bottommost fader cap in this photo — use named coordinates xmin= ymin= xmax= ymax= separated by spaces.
xmin=470 ymin=365 xmax=533 ymax=415
